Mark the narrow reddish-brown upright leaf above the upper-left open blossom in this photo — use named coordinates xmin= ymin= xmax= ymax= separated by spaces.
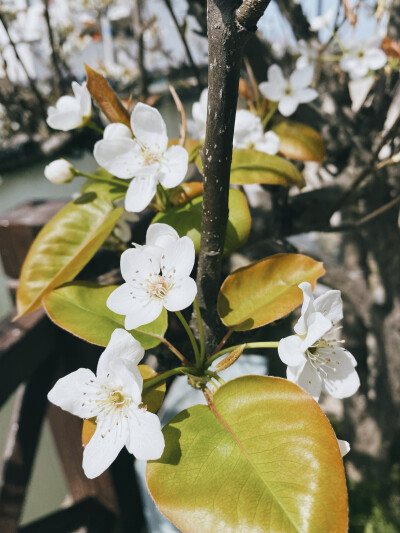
xmin=85 ymin=63 xmax=131 ymax=128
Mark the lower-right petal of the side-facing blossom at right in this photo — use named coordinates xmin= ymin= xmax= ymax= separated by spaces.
xmin=319 ymin=347 xmax=360 ymax=399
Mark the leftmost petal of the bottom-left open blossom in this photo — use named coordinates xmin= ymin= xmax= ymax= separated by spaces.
xmin=47 ymin=368 xmax=96 ymax=418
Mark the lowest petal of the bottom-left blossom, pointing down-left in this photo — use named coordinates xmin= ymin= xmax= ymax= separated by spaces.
xmin=82 ymin=417 xmax=129 ymax=479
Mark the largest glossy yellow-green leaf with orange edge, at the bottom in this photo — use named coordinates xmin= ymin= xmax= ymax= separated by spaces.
xmin=147 ymin=376 xmax=347 ymax=533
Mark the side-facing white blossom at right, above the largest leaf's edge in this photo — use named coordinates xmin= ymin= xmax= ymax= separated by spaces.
xmin=278 ymin=282 xmax=360 ymax=401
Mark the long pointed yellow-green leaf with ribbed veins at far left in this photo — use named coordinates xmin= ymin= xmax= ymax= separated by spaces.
xmin=17 ymin=182 xmax=126 ymax=317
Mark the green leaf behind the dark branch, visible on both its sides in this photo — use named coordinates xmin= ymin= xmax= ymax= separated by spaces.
xmin=152 ymin=189 xmax=251 ymax=255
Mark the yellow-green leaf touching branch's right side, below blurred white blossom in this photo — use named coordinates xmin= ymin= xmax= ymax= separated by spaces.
xmin=231 ymin=149 xmax=306 ymax=189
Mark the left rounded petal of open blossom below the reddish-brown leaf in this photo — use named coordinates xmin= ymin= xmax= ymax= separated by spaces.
xmin=93 ymin=137 xmax=144 ymax=179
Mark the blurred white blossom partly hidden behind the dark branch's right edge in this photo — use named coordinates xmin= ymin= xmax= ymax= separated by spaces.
xmin=233 ymin=109 xmax=280 ymax=155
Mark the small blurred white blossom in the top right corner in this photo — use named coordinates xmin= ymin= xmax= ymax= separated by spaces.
xmin=339 ymin=35 xmax=387 ymax=80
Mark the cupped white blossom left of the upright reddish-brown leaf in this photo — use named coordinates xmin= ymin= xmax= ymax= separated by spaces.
xmin=47 ymin=81 xmax=92 ymax=131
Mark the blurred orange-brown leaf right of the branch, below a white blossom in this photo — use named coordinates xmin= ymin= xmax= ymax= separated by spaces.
xmin=272 ymin=122 xmax=325 ymax=163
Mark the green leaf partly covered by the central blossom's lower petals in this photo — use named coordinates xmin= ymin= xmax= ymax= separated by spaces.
xmin=43 ymin=281 xmax=168 ymax=350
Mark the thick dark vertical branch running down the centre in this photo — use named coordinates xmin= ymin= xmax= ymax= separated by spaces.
xmin=197 ymin=0 xmax=274 ymax=353
